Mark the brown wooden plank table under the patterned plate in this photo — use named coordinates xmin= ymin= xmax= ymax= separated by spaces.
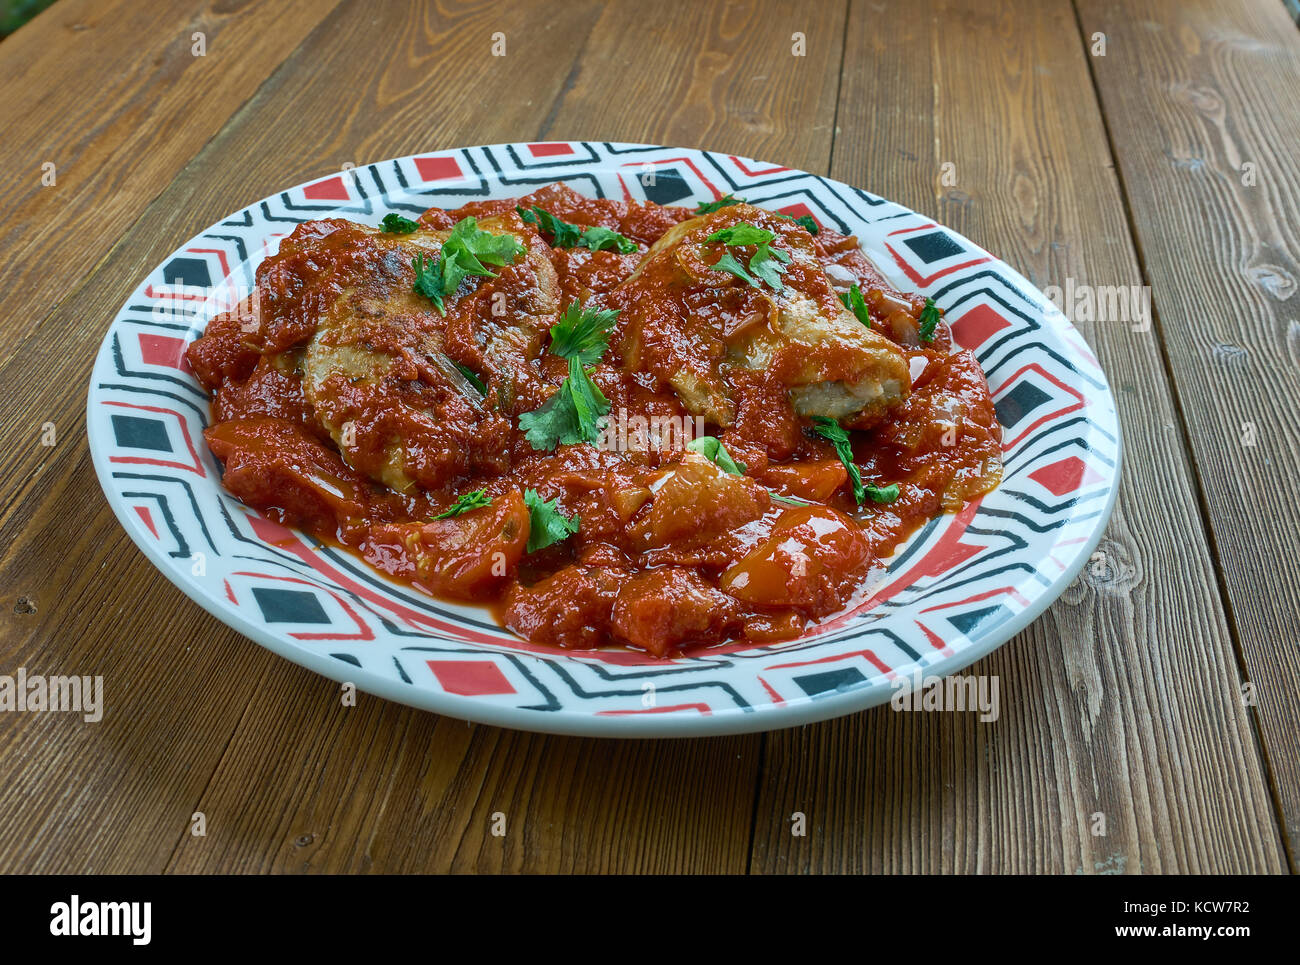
xmin=0 ymin=0 xmax=1300 ymax=874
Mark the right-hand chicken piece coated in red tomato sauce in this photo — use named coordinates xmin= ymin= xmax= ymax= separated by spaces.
xmin=608 ymin=204 xmax=910 ymax=442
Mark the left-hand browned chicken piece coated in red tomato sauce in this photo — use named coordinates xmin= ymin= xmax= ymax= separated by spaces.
xmin=303 ymin=216 xmax=559 ymax=492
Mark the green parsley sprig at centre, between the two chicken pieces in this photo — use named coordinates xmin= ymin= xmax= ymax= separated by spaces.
xmin=519 ymin=302 xmax=619 ymax=450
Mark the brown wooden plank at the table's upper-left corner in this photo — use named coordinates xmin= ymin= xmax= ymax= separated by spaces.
xmin=0 ymin=0 xmax=337 ymax=359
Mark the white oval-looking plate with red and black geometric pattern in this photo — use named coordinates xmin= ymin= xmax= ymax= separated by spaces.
xmin=86 ymin=142 xmax=1119 ymax=737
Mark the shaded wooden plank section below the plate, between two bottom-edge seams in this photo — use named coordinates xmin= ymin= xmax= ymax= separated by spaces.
xmin=169 ymin=681 xmax=758 ymax=874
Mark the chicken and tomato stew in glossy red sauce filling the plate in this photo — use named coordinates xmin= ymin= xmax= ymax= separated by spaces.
xmin=189 ymin=185 xmax=1001 ymax=657
